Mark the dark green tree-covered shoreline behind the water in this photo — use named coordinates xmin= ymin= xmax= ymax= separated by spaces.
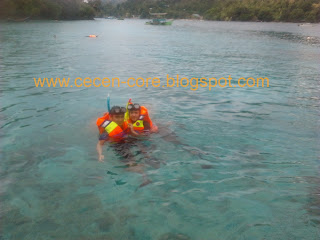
xmin=0 ymin=0 xmax=320 ymax=22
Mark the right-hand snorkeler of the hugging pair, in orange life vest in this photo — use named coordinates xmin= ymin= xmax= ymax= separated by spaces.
xmin=125 ymin=100 xmax=158 ymax=136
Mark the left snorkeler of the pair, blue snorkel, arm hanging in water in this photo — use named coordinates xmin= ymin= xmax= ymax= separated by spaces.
xmin=97 ymin=106 xmax=128 ymax=162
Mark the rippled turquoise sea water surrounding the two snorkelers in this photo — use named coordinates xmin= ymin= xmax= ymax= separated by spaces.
xmin=0 ymin=19 xmax=320 ymax=240
